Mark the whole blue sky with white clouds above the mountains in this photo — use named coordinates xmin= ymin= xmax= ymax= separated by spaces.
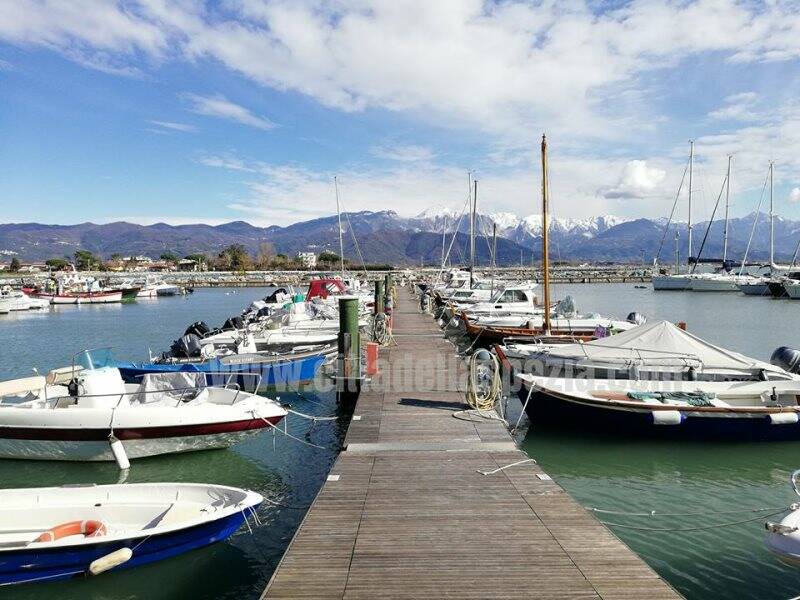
xmin=0 ymin=0 xmax=800 ymax=225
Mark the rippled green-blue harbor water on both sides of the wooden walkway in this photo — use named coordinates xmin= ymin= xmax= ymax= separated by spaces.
xmin=0 ymin=284 xmax=800 ymax=600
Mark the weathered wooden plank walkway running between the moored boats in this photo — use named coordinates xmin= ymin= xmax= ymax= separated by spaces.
xmin=263 ymin=289 xmax=680 ymax=600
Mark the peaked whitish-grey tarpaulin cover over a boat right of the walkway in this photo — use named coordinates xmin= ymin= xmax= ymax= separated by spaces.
xmin=512 ymin=321 xmax=785 ymax=374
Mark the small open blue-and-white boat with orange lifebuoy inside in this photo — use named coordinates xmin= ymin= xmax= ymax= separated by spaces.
xmin=0 ymin=483 xmax=264 ymax=585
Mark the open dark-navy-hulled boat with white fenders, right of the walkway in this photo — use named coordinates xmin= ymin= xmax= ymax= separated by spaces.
xmin=517 ymin=373 xmax=800 ymax=441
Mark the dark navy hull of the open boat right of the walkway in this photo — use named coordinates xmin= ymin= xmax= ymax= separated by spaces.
xmin=519 ymin=385 xmax=800 ymax=442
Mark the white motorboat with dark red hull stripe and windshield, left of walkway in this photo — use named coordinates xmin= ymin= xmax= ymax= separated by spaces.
xmin=0 ymin=350 xmax=286 ymax=462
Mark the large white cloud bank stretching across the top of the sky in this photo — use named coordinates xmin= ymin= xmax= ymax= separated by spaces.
xmin=0 ymin=0 xmax=800 ymax=141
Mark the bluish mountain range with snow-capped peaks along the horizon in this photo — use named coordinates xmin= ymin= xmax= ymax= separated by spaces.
xmin=0 ymin=209 xmax=800 ymax=265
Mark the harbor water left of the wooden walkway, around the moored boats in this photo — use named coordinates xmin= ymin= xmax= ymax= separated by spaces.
xmin=0 ymin=288 xmax=349 ymax=600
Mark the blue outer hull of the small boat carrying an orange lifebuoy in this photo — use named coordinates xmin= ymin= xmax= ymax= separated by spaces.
xmin=0 ymin=505 xmax=258 ymax=585
